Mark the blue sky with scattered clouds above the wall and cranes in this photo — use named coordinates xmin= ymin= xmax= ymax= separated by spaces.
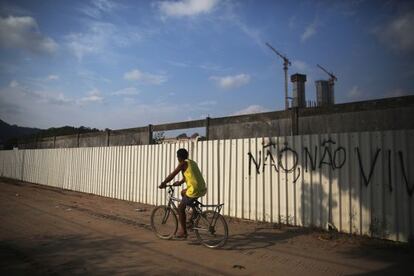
xmin=0 ymin=0 xmax=414 ymax=129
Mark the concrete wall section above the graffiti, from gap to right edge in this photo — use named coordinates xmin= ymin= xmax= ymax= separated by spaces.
xmin=208 ymin=96 xmax=414 ymax=140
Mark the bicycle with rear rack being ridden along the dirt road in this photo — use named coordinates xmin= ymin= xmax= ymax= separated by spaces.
xmin=151 ymin=185 xmax=228 ymax=248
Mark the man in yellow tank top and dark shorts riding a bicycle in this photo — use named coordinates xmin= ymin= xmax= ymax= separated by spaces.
xmin=158 ymin=149 xmax=207 ymax=239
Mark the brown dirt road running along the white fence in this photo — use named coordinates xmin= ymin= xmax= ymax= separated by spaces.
xmin=0 ymin=179 xmax=414 ymax=276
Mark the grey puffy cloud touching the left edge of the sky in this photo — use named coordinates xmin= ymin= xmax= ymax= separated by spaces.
xmin=0 ymin=16 xmax=58 ymax=54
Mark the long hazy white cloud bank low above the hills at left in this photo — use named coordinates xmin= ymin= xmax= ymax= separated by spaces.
xmin=0 ymin=84 xmax=173 ymax=129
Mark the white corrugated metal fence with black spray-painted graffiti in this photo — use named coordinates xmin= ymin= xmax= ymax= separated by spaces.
xmin=0 ymin=130 xmax=414 ymax=241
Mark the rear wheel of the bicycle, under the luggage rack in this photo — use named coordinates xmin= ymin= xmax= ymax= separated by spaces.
xmin=194 ymin=210 xmax=229 ymax=248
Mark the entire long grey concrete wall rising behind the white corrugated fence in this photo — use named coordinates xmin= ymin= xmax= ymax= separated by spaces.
xmin=19 ymin=96 xmax=414 ymax=148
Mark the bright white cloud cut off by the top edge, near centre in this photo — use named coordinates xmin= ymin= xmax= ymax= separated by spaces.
xmin=158 ymin=0 xmax=219 ymax=17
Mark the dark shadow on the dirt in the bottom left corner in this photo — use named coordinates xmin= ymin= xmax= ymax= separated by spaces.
xmin=0 ymin=235 xmax=155 ymax=275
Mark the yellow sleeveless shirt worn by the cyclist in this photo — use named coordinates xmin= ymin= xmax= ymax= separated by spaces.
xmin=184 ymin=159 xmax=207 ymax=198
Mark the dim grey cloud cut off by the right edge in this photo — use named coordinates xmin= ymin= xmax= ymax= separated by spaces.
xmin=374 ymin=11 xmax=414 ymax=51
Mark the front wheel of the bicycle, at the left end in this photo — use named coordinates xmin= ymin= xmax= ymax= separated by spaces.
xmin=151 ymin=205 xmax=178 ymax=240
